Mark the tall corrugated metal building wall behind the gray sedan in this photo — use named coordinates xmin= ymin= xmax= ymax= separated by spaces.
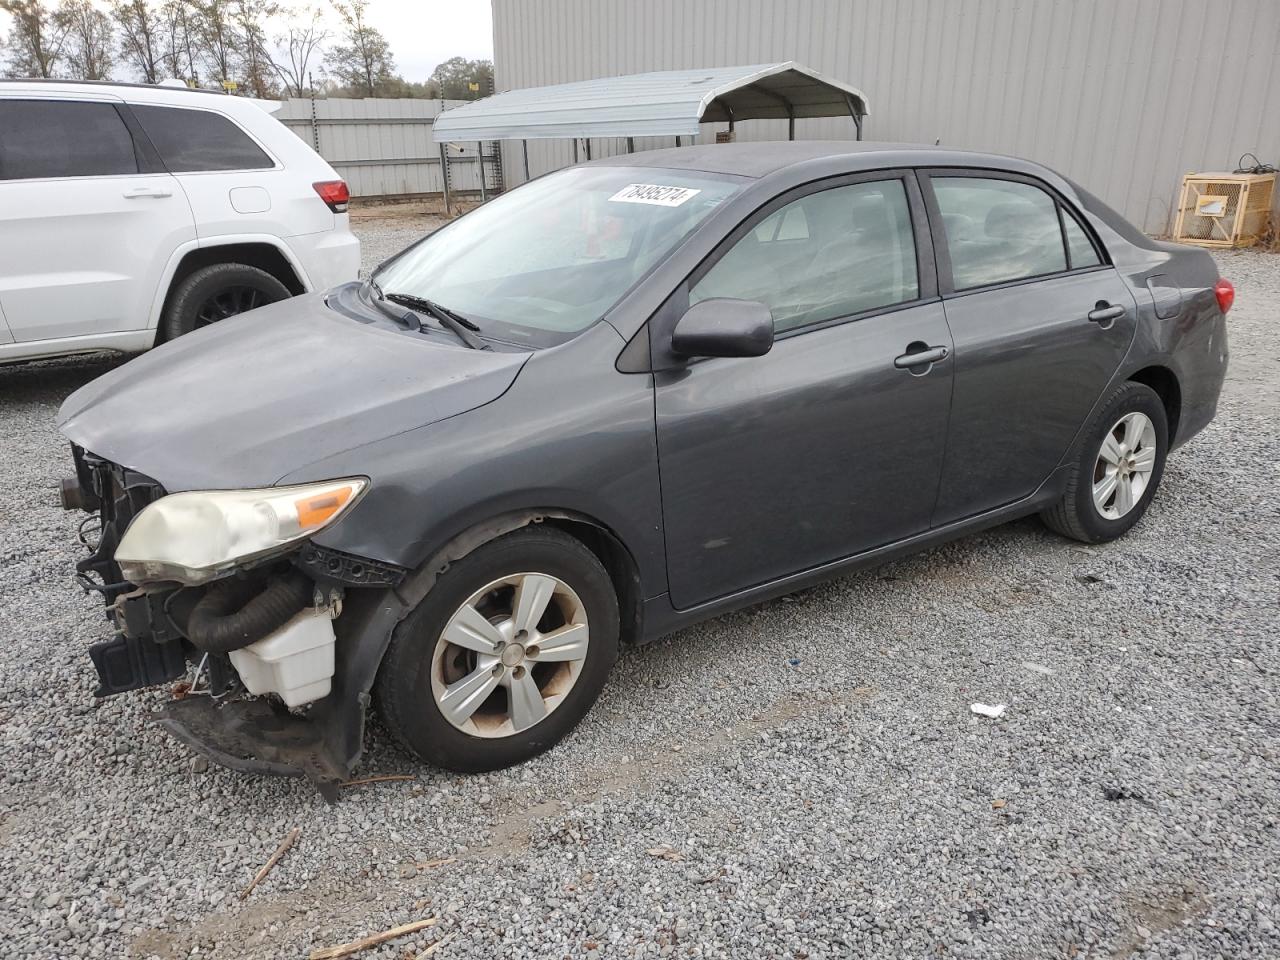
xmin=493 ymin=0 xmax=1280 ymax=233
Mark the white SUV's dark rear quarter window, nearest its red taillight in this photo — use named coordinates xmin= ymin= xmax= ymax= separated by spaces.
xmin=129 ymin=104 xmax=274 ymax=173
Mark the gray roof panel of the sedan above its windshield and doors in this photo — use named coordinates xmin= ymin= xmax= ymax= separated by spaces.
xmin=591 ymin=140 xmax=1048 ymax=179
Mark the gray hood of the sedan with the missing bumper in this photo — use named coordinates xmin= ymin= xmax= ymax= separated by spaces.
xmin=58 ymin=294 xmax=530 ymax=493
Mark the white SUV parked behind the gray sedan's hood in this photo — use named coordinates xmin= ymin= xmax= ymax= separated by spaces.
xmin=0 ymin=81 xmax=360 ymax=362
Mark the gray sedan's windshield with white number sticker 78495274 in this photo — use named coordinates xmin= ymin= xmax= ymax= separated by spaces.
xmin=376 ymin=166 xmax=741 ymax=346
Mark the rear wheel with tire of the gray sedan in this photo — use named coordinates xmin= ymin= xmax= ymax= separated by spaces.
xmin=1041 ymin=381 xmax=1169 ymax=543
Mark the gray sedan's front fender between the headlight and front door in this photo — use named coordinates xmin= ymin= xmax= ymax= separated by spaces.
xmin=288 ymin=324 xmax=667 ymax=604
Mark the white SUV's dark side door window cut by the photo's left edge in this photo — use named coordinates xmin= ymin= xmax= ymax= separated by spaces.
xmin=0 ymin=100 xmax=138 ymax=180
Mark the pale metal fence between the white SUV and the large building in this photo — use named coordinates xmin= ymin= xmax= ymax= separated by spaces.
xmin=275 ymin=97 xmax=494 ymax=197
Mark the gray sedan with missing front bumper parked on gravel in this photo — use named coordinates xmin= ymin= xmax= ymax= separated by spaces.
xmin=60 ymin=143 xmax=1233 ymax=796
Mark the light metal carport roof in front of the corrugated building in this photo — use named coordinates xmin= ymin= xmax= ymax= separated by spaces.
xmin=435 ymin=60 xmax=868 ymax=143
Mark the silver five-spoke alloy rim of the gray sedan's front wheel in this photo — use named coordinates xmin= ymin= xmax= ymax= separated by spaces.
xmin=431 ymin=572 xmax=590 ymax=737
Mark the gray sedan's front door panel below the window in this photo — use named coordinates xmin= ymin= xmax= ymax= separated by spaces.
xmin=655 ymin=302 xmax=951 ymax=607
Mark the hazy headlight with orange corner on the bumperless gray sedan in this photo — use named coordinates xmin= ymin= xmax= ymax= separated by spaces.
xmin=115 ymin=477 xmax=369 ymax=585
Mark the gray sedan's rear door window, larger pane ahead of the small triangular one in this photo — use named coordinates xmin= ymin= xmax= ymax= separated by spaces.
xmin=932 ymin=177 xmax=1068 ymax=291
